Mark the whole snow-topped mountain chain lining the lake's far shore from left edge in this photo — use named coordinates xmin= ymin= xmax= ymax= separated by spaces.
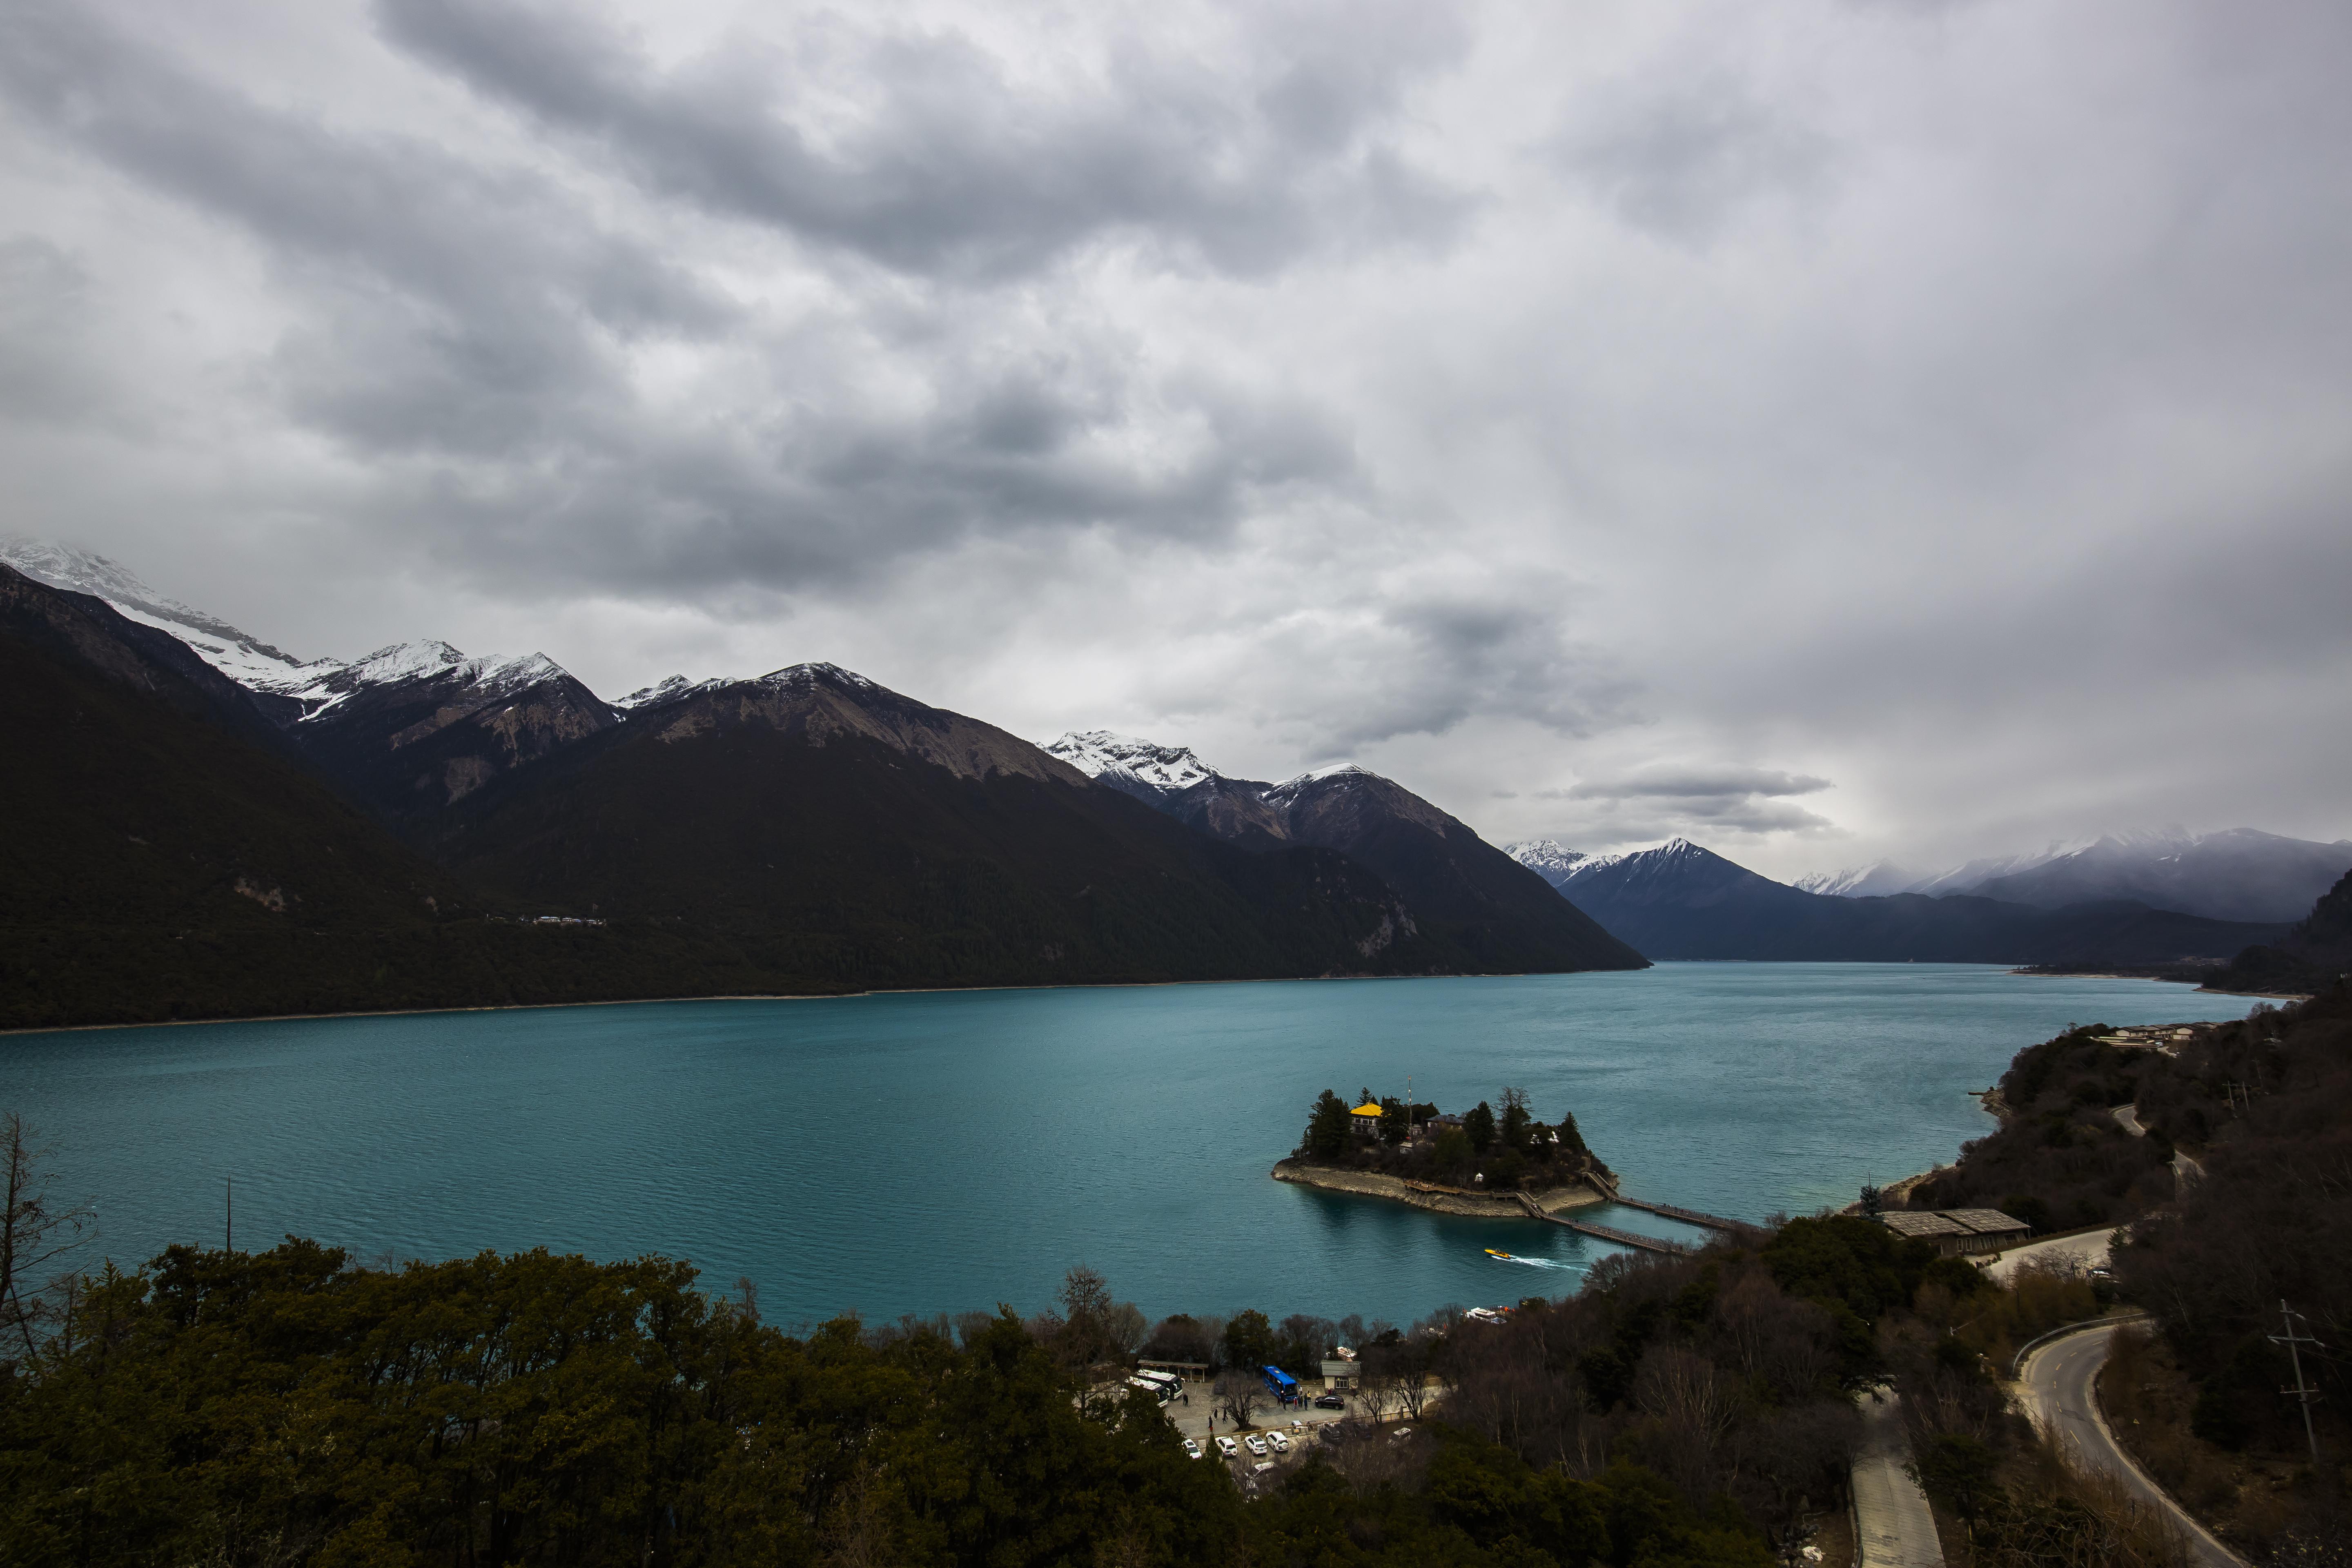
xmin=0 ymin=543 xmax=1644 ymax=1027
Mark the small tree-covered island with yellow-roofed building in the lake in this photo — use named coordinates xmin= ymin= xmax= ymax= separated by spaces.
xmin=1272 ymin=1089 xmax=1616 ymax=1218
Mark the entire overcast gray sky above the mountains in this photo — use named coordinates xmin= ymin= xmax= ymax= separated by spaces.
xmin=0 ymin=0 xmax=2352 ymax=875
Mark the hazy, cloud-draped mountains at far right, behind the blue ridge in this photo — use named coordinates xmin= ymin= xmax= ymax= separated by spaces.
xmin=1795 ymin=828 xmax=2352 ymax=922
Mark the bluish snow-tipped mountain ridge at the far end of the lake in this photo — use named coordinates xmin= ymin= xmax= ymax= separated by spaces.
xmin=1512 ymin=839 xmax=2286 ymax=964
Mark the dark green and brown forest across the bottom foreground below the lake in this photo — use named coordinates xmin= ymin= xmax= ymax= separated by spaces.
xmin=0 ymin=1189 xmax=2140 ymax=1568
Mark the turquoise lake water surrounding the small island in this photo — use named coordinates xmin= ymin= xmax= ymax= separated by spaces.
xmin=0 ymin=964 xmax=2253 ymax=1326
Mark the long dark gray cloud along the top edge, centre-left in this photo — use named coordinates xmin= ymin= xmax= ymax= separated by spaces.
xmin=379 ymin=0 xmax=1465 ymax=275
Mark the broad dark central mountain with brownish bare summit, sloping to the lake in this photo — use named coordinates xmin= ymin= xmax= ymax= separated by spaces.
xmin=433 ymin=665 xmax=1618 ymax=985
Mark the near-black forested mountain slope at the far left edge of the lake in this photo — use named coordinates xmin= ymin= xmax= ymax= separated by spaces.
xmin=0 ymin=566 xmax=519 ymax=1027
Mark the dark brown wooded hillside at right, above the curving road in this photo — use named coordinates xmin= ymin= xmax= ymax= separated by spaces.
xmin=1912 ymin=982 xmax=2352 ymax=1563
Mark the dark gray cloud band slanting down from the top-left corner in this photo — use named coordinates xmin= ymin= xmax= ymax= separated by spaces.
xmin=0 ymin=0 xmax=731 ymax=454
